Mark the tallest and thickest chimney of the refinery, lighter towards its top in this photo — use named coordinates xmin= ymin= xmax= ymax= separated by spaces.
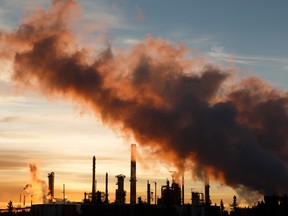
xmin=130 ymin=144 xmax=136 ymax=205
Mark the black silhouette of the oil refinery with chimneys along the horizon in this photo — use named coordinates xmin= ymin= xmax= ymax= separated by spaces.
xmin=0 ymin=144 xmax=288 ymax=216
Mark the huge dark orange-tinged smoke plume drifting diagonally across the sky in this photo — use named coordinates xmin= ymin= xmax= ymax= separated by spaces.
xmin=0 ymin=0 xmax=288 ymax=201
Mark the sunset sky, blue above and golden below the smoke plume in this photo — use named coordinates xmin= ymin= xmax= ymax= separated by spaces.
xmin=0 ymin=0 xmax=288 ymax=208
